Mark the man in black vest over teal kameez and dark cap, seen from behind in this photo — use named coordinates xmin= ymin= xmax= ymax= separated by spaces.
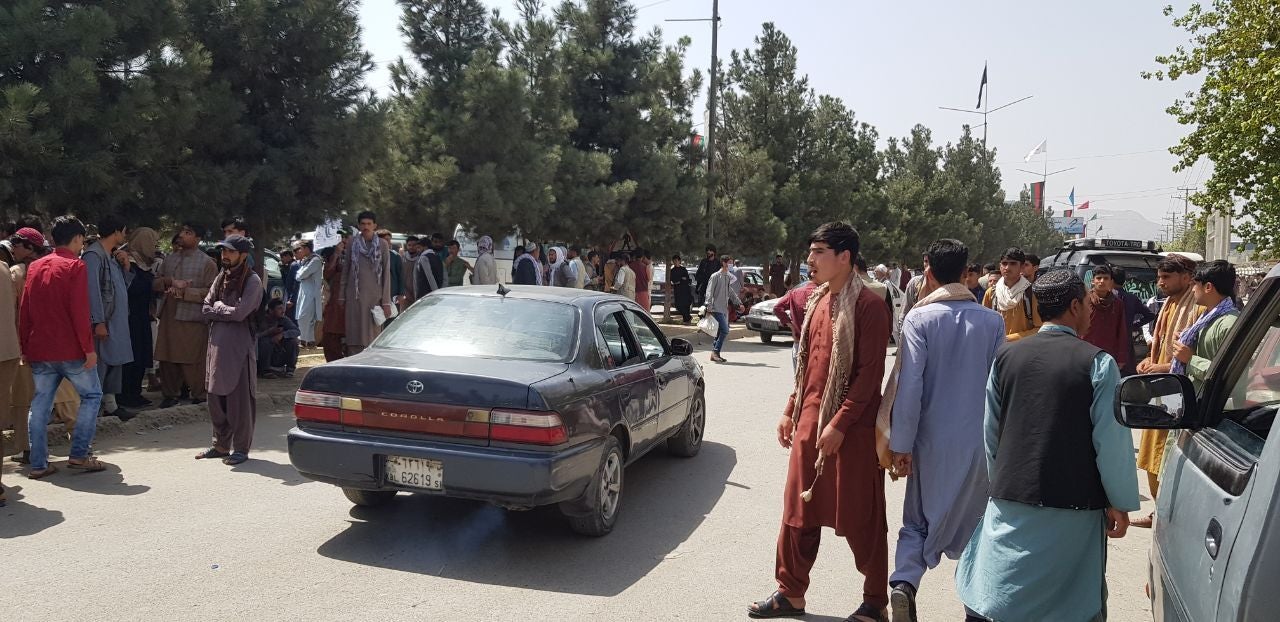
xmin=956 ymin=270 xmax=1138 ymax=622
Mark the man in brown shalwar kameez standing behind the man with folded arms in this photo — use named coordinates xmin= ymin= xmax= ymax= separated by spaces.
xmin=152 ymin=224 xmax=218 ymax=408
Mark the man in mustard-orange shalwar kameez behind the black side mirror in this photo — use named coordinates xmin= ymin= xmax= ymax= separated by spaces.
xmin=1132 ymin=255 xmax=1204 ymax=529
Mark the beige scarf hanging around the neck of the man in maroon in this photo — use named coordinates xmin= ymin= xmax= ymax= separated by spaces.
xmin=790 ymin=274 xmax=863 ymax=500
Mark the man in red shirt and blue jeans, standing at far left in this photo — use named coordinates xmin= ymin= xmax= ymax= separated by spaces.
xmin=18 ymin=216 xmax=106 ymax=480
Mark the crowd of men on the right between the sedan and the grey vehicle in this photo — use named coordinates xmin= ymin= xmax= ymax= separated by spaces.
xmin=748 ymin=223 xmax=1239 ymax=622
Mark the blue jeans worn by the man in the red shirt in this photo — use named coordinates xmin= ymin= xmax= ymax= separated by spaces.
xmin=27 ymin=358 xmax=102 ymax=471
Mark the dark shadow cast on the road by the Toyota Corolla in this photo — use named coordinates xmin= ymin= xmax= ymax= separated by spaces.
xmin=317 ymin=443 xmax=737 ymax=596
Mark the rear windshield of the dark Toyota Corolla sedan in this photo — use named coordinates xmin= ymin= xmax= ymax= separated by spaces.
xmin=371 ymin=294 xmax=577 ymax=362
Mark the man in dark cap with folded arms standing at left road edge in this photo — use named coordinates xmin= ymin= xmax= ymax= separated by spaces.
xmin=196 ymin=234 xmax=262 ymax=465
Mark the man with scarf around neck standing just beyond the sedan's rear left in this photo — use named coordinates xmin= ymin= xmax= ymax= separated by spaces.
xmin=338 ymin=211 xmax=392 ymax=356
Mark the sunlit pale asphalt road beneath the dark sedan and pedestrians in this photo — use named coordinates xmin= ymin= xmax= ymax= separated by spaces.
xmin=0 ymin=339 xmax=1151 ymax=621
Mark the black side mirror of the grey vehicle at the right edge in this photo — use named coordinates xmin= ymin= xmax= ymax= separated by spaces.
xmin=1116 ymin=374 xmax=1196 ymax=430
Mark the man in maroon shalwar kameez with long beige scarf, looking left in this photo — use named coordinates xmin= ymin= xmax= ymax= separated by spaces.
xmin=748 ymin=223 xmax=890 ymax=621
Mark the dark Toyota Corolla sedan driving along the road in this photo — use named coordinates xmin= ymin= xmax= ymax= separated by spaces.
xmin=289 ymin=285 xmax=707 ymax=536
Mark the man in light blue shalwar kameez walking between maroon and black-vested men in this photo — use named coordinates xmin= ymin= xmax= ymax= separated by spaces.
xmin=890 ymin=239 xmax=1005 ymax=622
